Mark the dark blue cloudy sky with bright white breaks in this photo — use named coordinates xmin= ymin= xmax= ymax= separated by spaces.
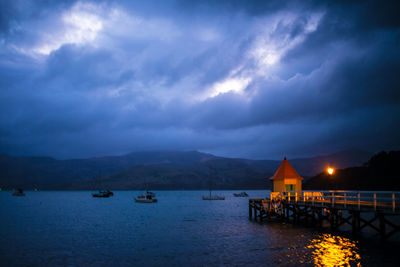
xmin=0 ymin=0 xmax=400 ymax=158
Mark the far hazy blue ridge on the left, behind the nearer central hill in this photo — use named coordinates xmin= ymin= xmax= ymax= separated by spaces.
xmin=0 ymin=151 xmax=217 ymax=189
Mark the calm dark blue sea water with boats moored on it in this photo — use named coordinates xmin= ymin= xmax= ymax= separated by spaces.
xmin=0 ymin=191 xmax=400 ymax=266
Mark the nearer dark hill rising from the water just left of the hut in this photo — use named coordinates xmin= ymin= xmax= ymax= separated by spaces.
xmin=71 ymin=158 xmax=272 ymax=190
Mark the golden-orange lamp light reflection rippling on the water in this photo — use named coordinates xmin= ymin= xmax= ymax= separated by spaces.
xmin=308 ymin=234 xmax=361 ymax=266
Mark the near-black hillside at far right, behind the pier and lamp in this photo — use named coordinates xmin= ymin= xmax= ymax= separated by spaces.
xmin=303 ymin=151 xmax=400 ymax=190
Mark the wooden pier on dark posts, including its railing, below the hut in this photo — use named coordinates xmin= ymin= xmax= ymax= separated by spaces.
xmin=249 ymin=191 xmax=400 ymax=239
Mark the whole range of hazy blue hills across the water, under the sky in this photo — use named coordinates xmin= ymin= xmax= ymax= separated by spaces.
xmin=0 ymin=150 xmax=367 ymax=189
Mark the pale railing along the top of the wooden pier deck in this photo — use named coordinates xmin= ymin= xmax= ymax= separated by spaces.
xmin=271 ymin=190 xmax=400 ymax=213
